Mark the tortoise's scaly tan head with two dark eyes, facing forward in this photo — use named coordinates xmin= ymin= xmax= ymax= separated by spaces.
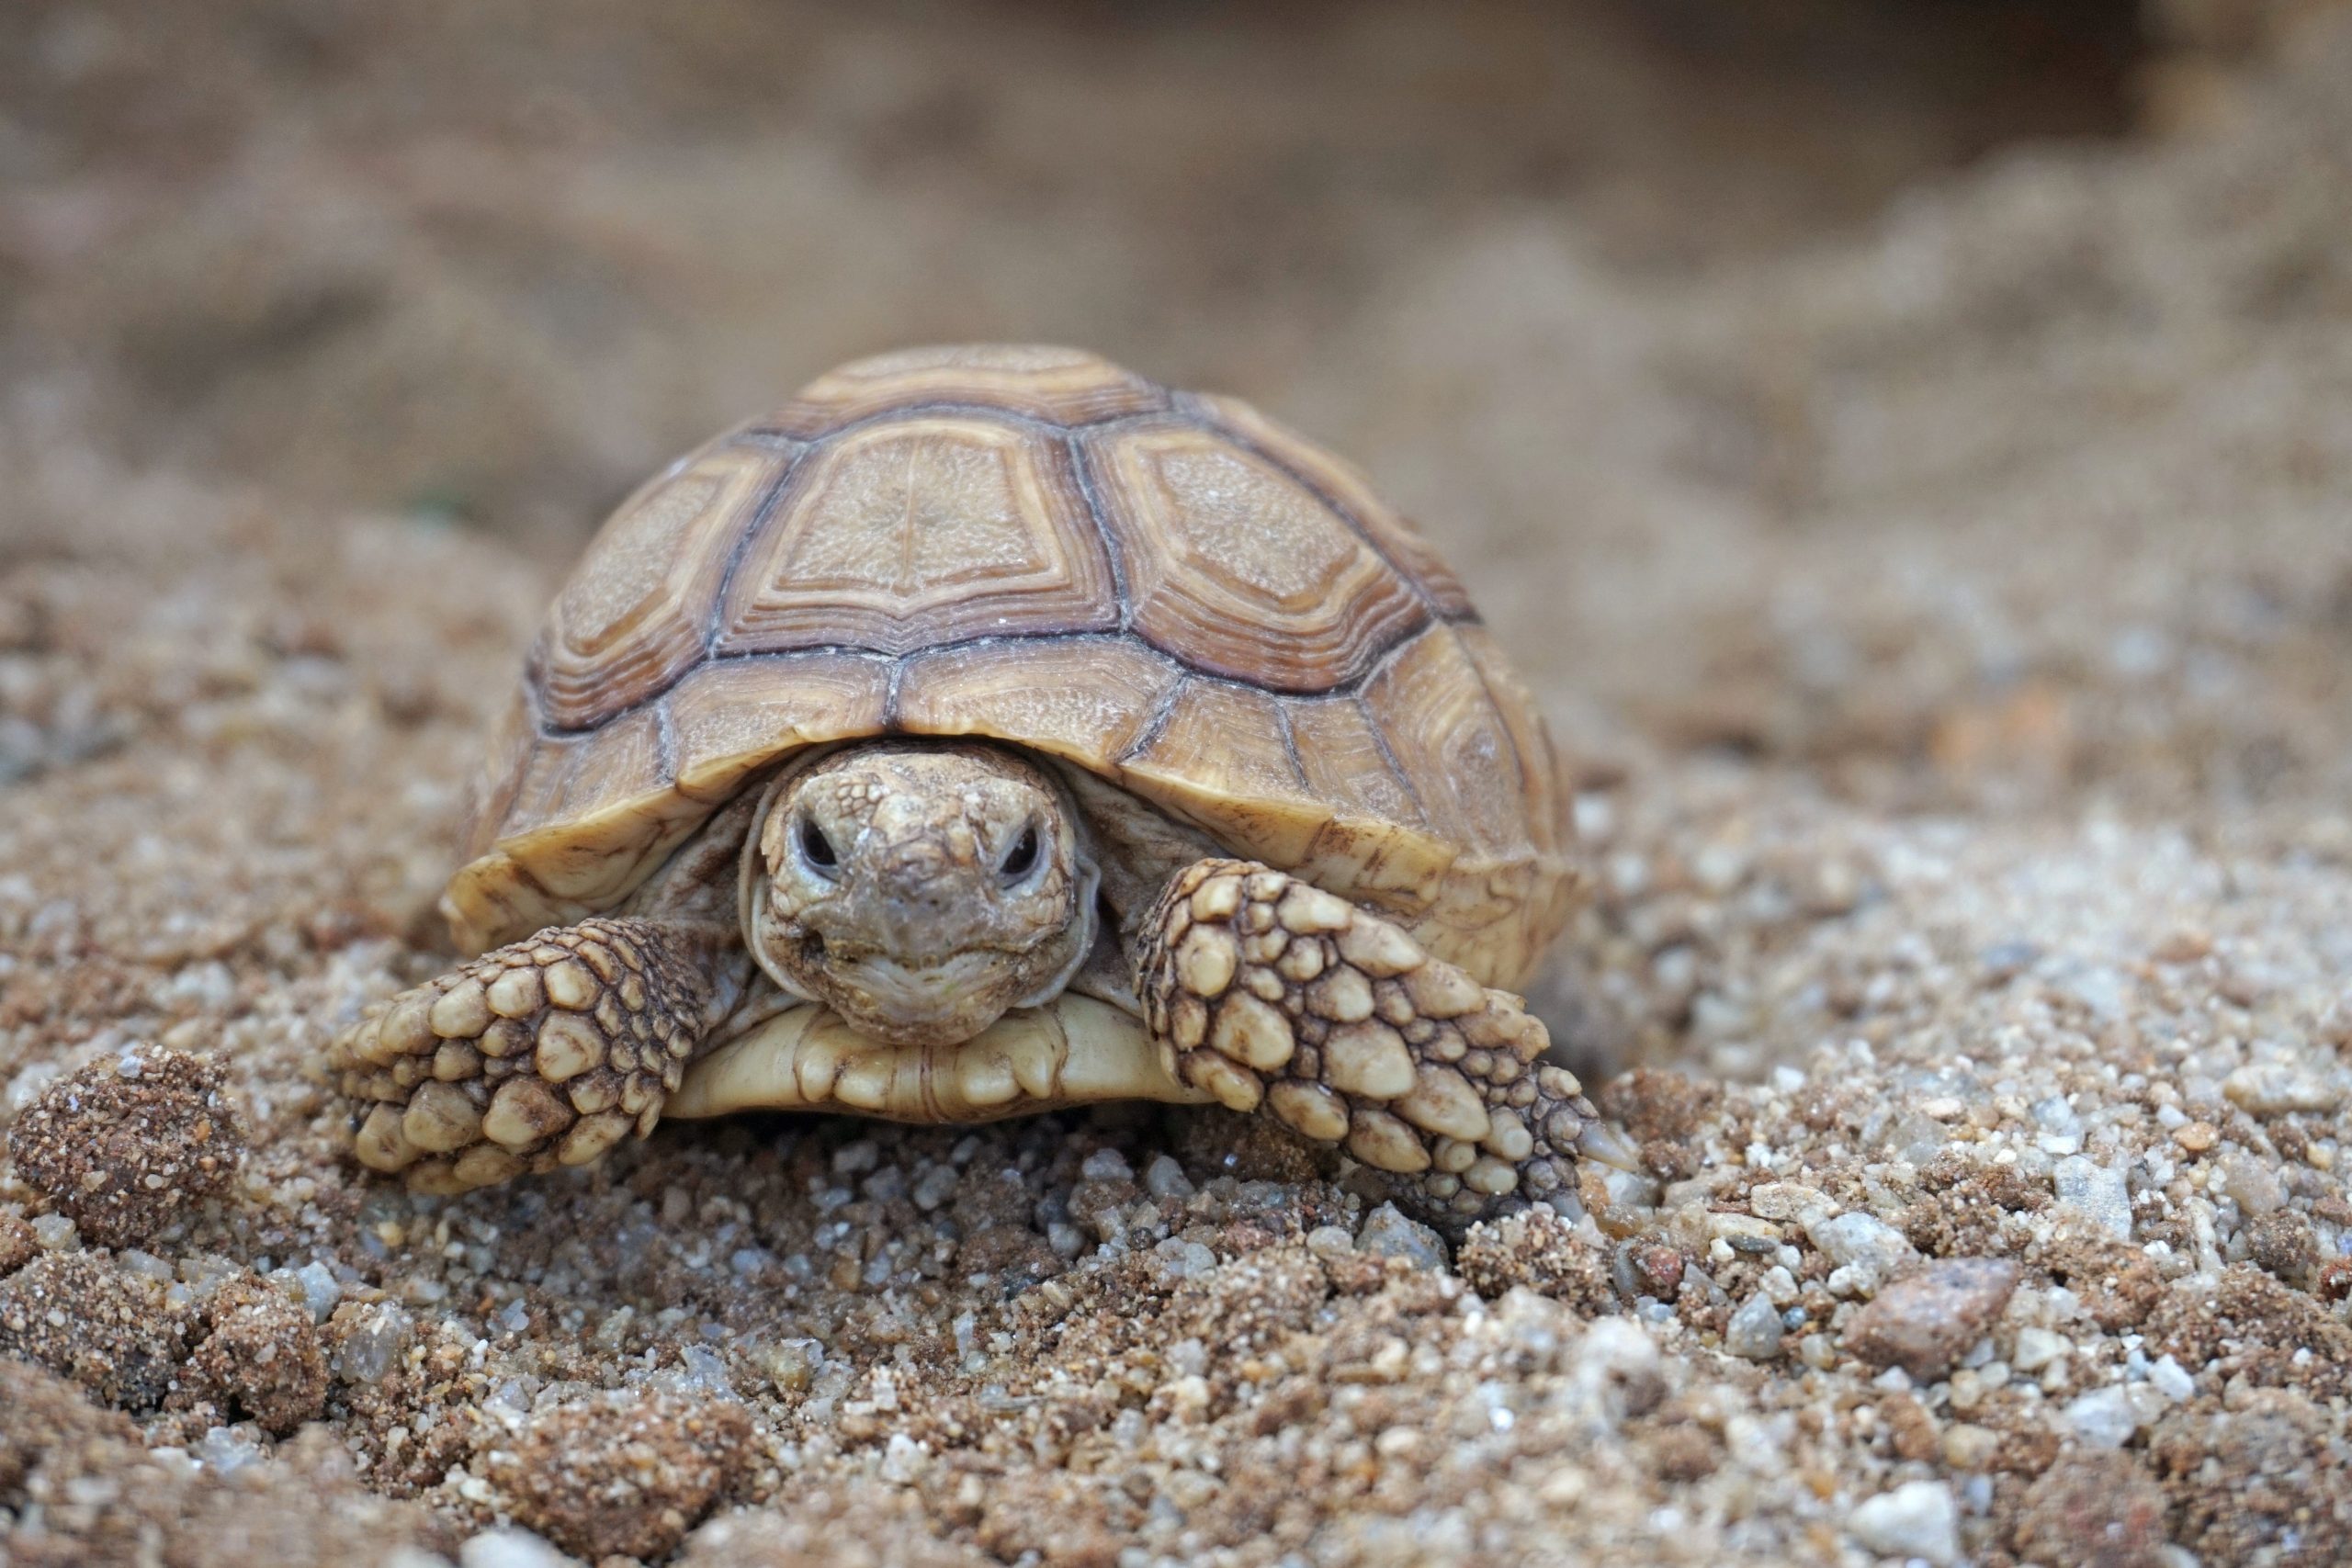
xmin=743 ymin=740 xmax=1096 ymax=1046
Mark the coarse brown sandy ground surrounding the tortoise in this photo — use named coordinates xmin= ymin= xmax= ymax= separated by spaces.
xmin=0 ymin=7 xmax=2352 ymax=1568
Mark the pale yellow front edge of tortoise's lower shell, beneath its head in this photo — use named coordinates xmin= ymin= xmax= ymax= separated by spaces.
xmin=663 ymin=992 xmax=1209 ymax=1122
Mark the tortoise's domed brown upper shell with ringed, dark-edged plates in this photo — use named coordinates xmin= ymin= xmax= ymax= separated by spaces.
xmin=445 ymin=348 xmax=1574 ymax=985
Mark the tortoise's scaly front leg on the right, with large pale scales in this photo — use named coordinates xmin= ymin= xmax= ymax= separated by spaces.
xmin=1136 ymin=861 xmax=1597 ymax=1223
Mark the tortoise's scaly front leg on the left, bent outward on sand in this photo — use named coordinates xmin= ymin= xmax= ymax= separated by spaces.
xmin=327 ymin=917 xmax=719 ymax=1192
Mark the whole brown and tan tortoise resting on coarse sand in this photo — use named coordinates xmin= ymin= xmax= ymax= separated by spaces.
xmin=329 ymin=345 xmax=1597 ymax=1220
